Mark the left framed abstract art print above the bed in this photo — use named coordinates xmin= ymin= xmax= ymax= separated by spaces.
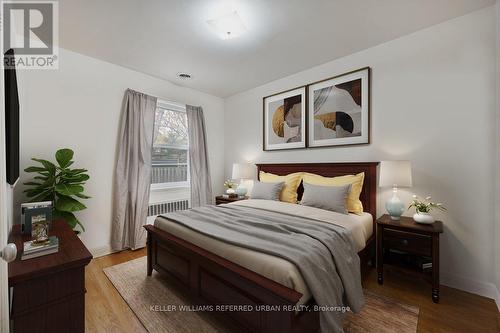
xmin=263 ymin=86 xmax=307 ymax=150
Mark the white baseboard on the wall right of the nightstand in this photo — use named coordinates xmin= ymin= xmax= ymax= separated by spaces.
xmin=441 ymin=274 xmax=500 ymax=312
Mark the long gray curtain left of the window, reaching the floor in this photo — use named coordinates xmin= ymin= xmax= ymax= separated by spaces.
xmin=111 ymin=89 xmax=156 ymax=251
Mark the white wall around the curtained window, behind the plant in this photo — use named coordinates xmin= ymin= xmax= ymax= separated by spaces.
xmin=15 ymin=49 xmax=224 ymax=253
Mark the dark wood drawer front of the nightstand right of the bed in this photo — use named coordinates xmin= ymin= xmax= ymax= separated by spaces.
xmin=384 ymin=228 xmax=432 ymax=256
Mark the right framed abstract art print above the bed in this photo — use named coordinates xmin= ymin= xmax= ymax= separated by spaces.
xmin=308 ymin=67 xmax=370 ymax=147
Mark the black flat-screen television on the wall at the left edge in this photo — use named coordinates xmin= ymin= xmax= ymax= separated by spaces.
xmin=3 ymin=49 xmax=19 ymax=185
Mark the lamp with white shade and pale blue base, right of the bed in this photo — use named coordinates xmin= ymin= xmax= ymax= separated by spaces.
xmin=379 ymin=161 xmax=412 ymax=220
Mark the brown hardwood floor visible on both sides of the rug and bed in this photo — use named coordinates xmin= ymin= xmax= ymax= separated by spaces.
xmin=85 ymin=249 xmax=500 ymax=333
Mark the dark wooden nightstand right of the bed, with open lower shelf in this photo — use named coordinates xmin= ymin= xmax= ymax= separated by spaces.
xmin=377 ymin=215 xmax=443 ymax=303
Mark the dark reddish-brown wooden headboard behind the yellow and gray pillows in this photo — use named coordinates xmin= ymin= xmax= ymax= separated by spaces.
xmin=256 ymin=162 xmax=378 ymax=221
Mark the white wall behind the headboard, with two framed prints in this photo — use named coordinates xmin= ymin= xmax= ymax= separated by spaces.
xmin=225 ymin=7 xmax=495 ymax=296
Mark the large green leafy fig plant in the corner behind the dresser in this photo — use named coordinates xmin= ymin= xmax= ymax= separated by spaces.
xmin=24 ymin=148 xmax=90 ymax=231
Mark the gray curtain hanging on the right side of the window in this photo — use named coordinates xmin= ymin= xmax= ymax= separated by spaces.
xmin=186 ymin=105 xmax=213 ymax=207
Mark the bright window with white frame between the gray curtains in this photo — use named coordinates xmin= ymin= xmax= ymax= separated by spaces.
xmin=151 ymin=101 xmax=189 ymax=189
